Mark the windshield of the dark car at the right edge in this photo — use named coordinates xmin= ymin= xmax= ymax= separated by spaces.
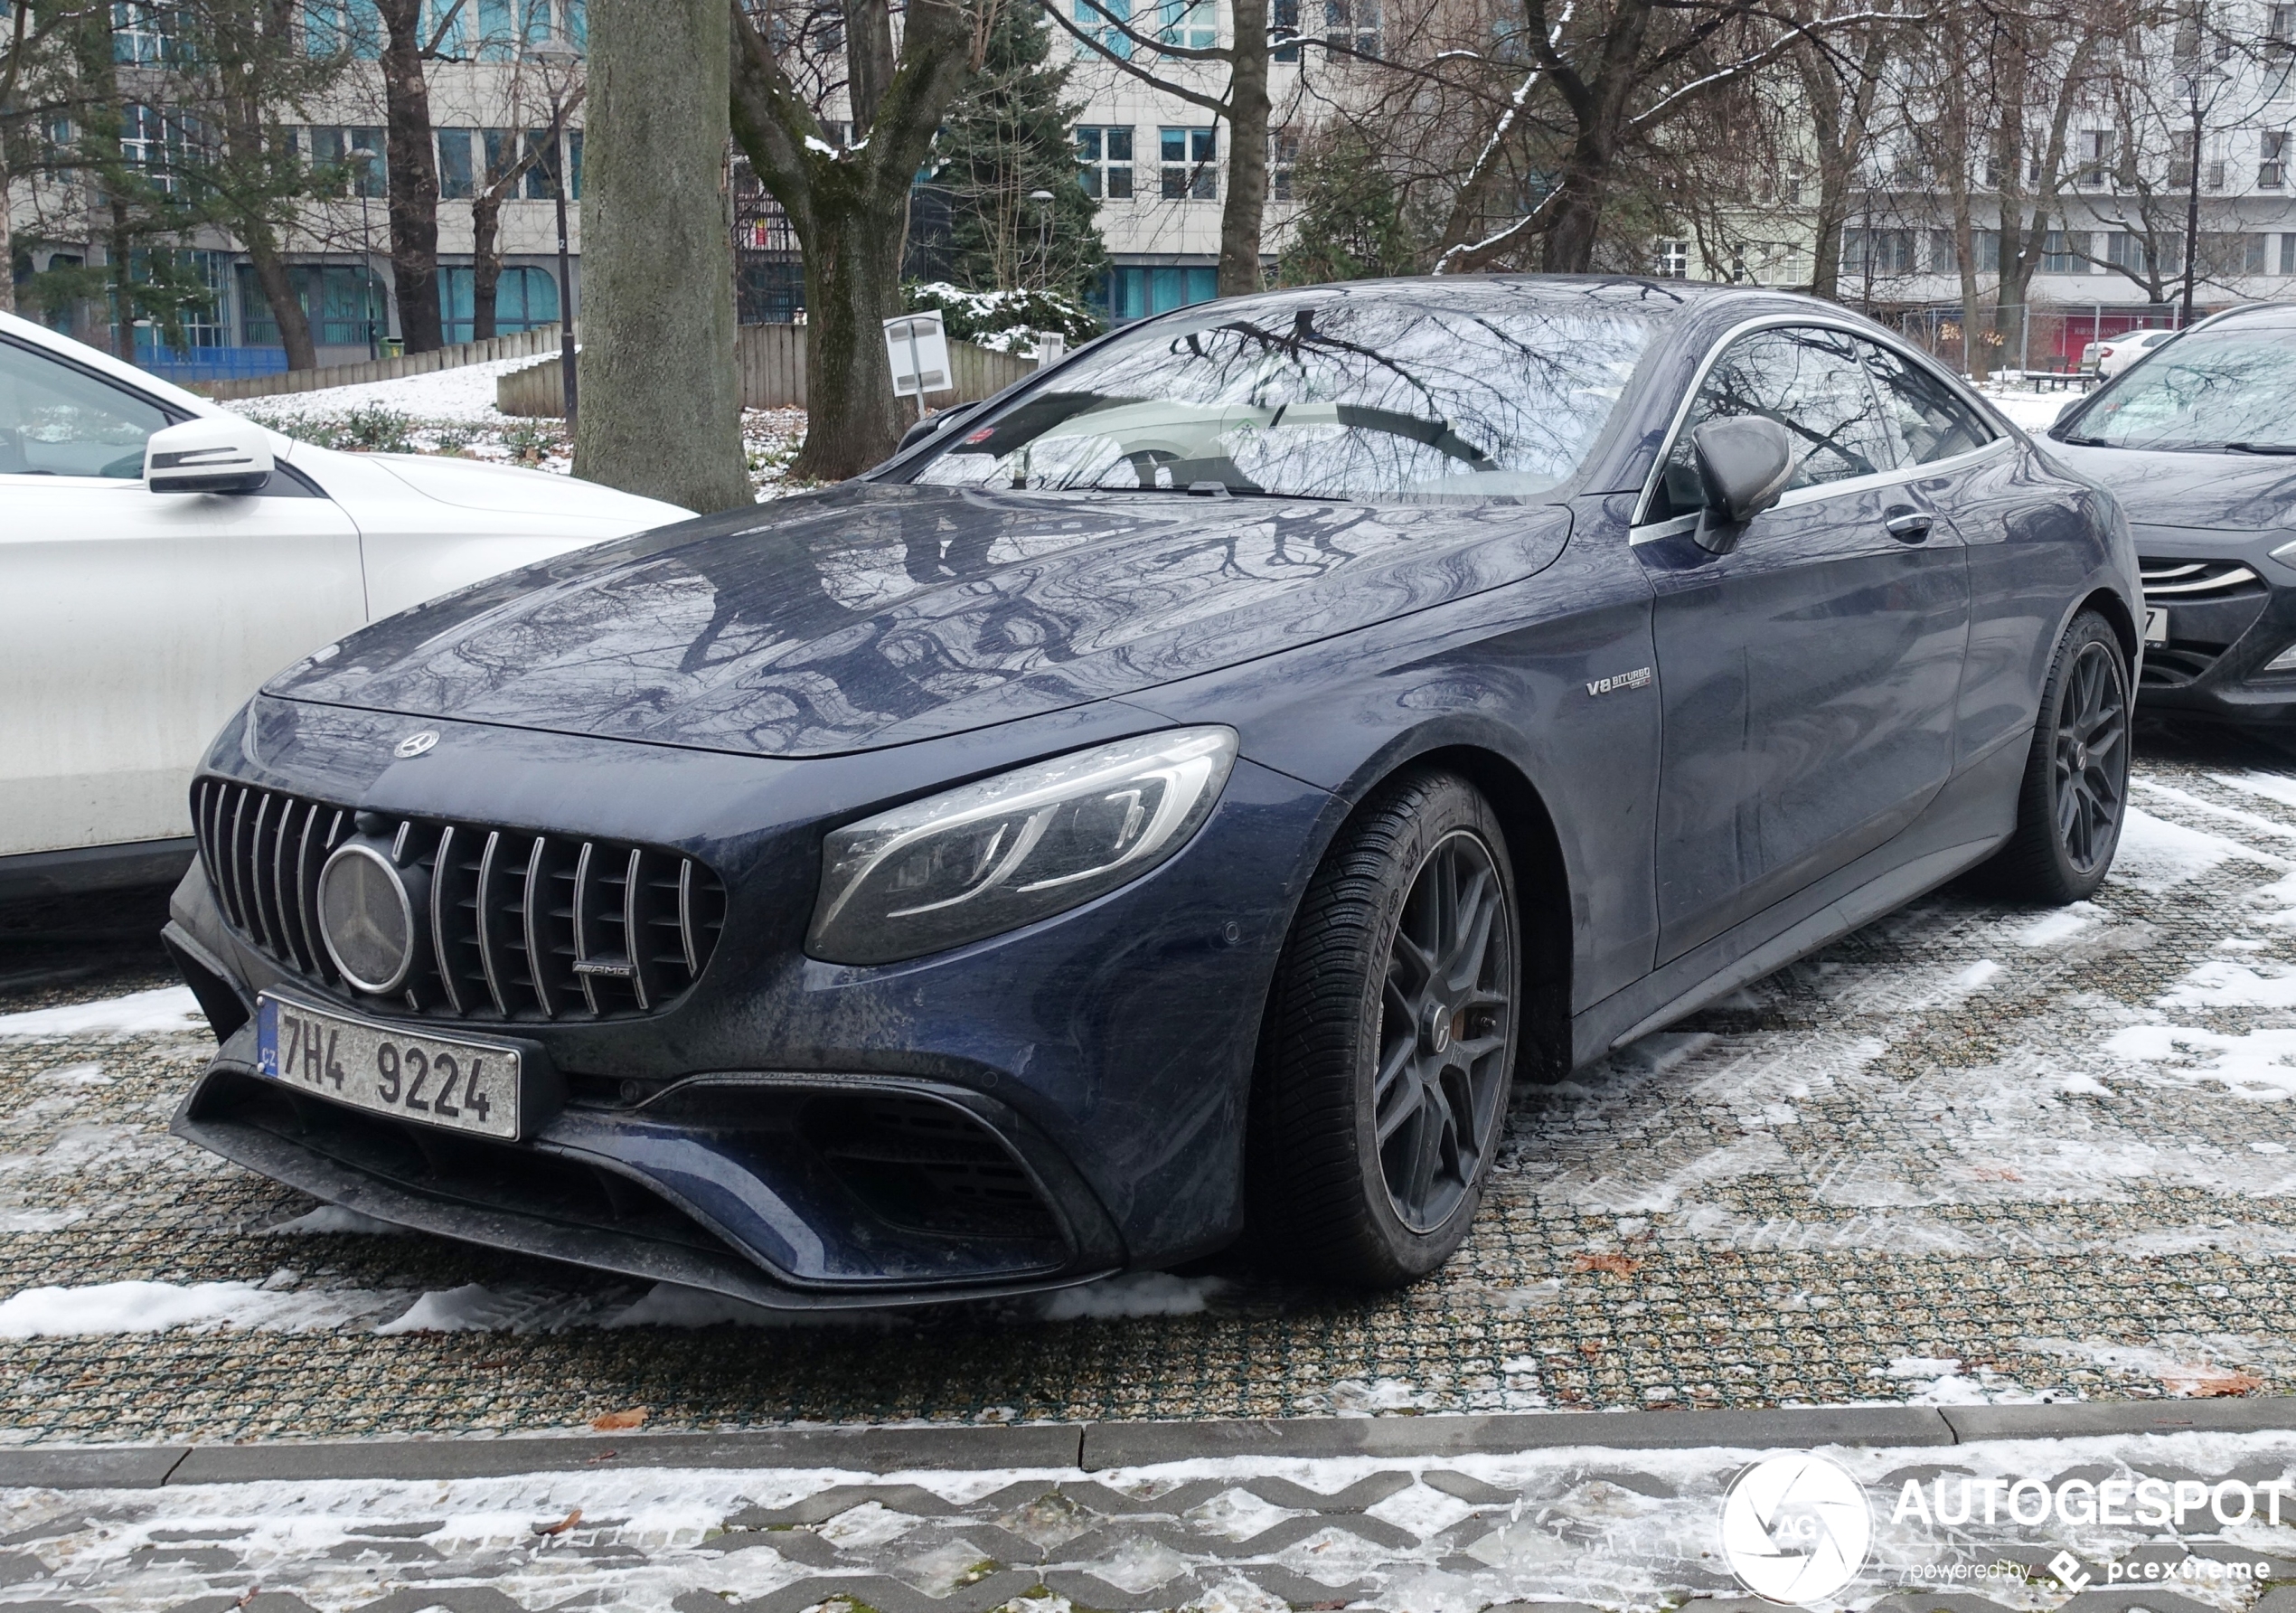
xmin=2055 ymin=326 xmax=2296 ymax=453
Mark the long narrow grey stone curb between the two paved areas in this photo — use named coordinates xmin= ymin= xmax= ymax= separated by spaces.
xmin=0 ymin=1395 xmax=2296 ymax=1489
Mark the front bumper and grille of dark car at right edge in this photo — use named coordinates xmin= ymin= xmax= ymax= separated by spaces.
xmin=2138 ymin=540 xmax=2296 ymax=724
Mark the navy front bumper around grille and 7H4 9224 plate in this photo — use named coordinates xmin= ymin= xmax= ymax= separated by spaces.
xmin=167 ymin=701 xmax=1331 ymax=1310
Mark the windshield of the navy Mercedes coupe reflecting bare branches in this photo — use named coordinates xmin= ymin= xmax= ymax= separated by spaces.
xmin=914 ymin=288 xmax=1651 ymax=498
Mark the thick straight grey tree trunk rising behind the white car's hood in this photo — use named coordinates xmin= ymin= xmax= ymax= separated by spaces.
xmin=574 ymin=0 xmax=743 ymax=510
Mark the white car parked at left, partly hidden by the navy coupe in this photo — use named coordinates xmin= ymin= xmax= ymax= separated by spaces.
xmin=0 ymin=315 xmax=689 ymax=899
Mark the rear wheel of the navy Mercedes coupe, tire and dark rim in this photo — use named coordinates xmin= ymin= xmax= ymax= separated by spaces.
xmin=1986 ymin=611 xmax=2133 ymax=908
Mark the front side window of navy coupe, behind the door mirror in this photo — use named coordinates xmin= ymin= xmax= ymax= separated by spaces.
xmin=1649 ymin=326 xmax=1896 ymax=522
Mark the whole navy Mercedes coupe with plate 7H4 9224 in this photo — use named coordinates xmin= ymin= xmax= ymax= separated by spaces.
xmin=167 ymin=278 xmax=2140 ymax=1307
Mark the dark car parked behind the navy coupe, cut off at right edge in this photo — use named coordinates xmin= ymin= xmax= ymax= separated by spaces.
xmin=2048 ymin=306 xmax=2296 ymax=724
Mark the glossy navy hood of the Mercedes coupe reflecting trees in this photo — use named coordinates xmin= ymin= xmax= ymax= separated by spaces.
xmin=256 ymin=483 xmax=1570 ymax=756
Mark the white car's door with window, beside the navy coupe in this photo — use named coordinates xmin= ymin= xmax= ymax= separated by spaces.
xmin=0 ymin=338 xmax=365 ymax=857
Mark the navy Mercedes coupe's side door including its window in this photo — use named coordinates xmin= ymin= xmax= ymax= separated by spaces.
xmin=1634 ymin=324 xmax=1970 ymax=963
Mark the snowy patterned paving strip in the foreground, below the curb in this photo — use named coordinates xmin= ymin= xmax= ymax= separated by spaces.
xmin=13 ymin=1434 xmax=2296 ymax=1613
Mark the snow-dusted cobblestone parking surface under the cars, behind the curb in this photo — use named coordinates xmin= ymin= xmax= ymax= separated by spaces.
xmin=0 ymin=740 xmax=2296 ymax=1440
